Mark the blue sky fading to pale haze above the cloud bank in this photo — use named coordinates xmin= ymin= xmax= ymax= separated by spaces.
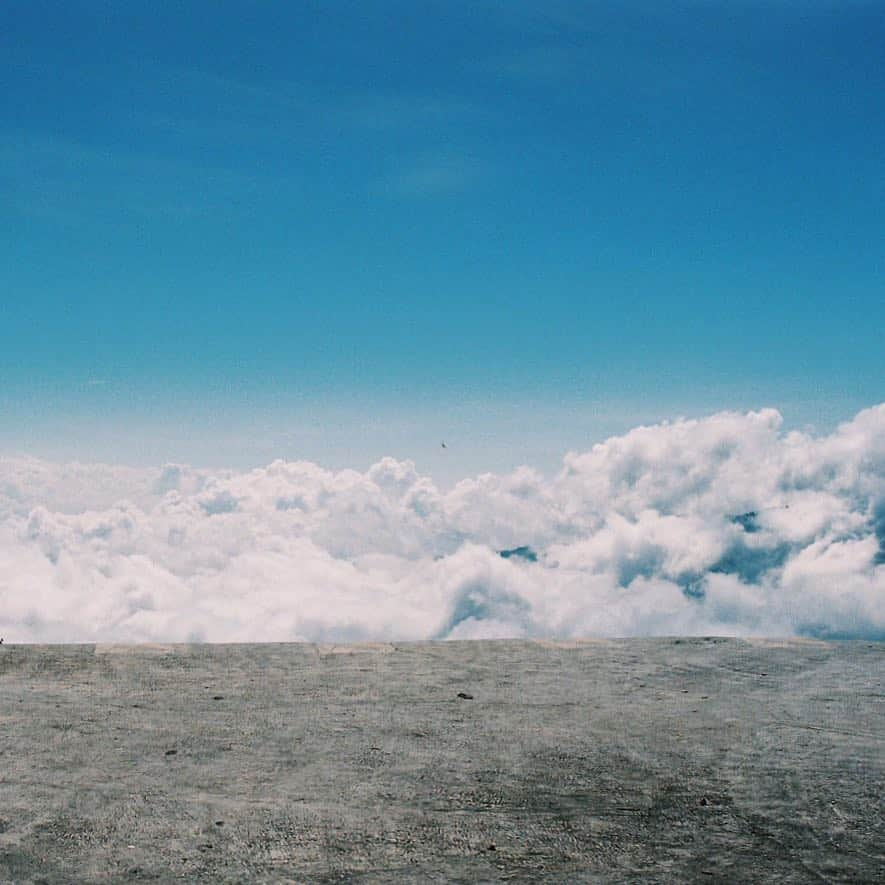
xmin=0 ymin=0 xmax=885 ymax=484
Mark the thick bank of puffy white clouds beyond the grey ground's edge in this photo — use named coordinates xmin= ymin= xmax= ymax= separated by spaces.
xmin=0 ymin=404 xmax=885 ymax=642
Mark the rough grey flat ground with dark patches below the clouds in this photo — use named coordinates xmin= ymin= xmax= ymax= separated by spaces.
xmin=0 ymin=639 xmax=885 ymax=883
